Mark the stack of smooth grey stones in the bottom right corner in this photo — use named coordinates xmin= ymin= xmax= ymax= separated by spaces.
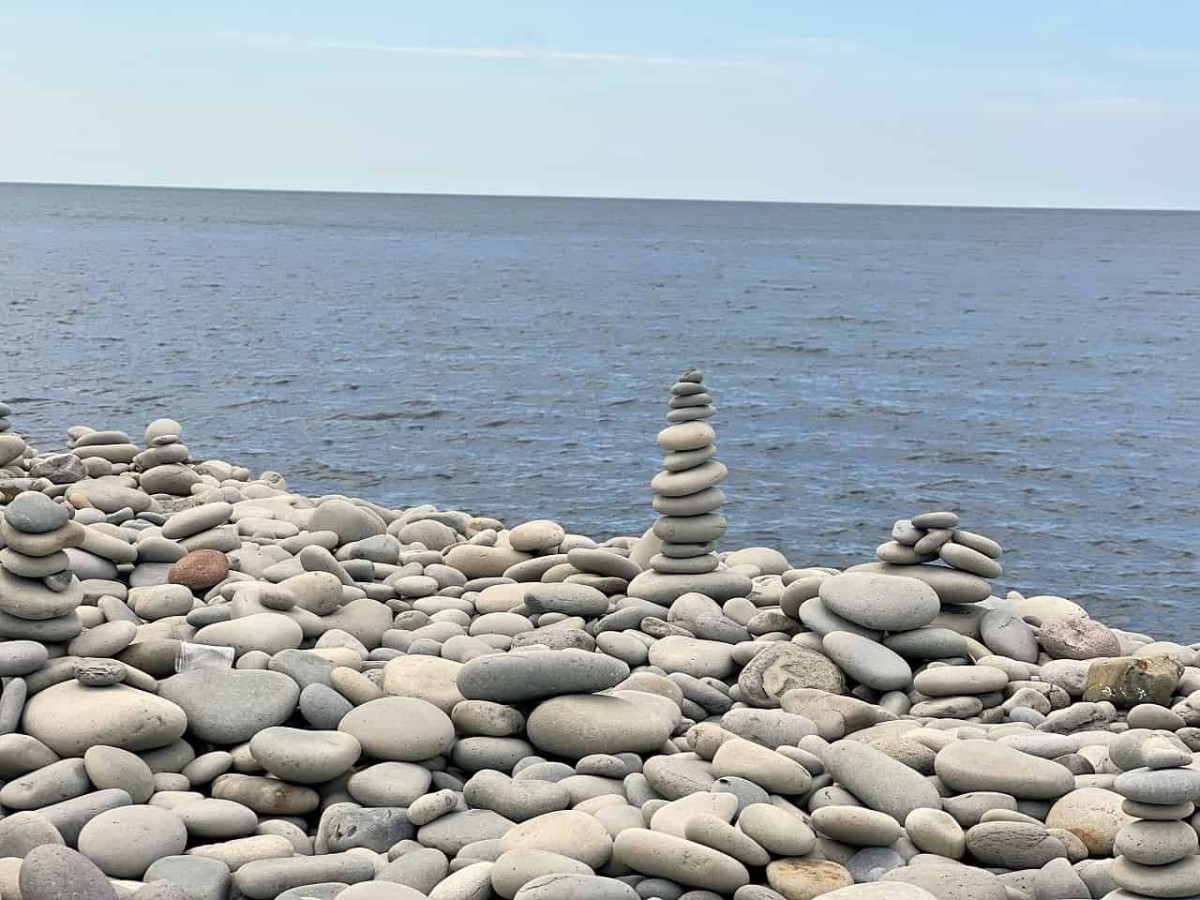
xmin=1110 ymin=732 xmax=1200 ymax=898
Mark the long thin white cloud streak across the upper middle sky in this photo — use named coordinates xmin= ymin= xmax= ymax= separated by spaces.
xmin=234 ymin=35 xmax=766 ymax=70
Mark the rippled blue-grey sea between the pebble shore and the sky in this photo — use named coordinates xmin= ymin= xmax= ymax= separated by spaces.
xmin=0 ymin=185 xmax=1200 ymax=641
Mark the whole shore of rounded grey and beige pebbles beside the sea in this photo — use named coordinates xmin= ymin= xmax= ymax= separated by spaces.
xmin=0 ymin=393 xmax=1200 ymax=900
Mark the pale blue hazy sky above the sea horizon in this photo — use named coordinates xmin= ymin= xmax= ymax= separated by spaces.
xmin=0 ymin=0 xmax=1200 ymax=209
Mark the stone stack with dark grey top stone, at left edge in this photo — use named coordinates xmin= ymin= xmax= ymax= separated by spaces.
xmin=0 ymin=491 xmax=84 ymax=642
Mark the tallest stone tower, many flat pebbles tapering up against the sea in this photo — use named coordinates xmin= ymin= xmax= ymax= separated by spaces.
xmin=630 ymin=368 xmax=749 ymax=602
